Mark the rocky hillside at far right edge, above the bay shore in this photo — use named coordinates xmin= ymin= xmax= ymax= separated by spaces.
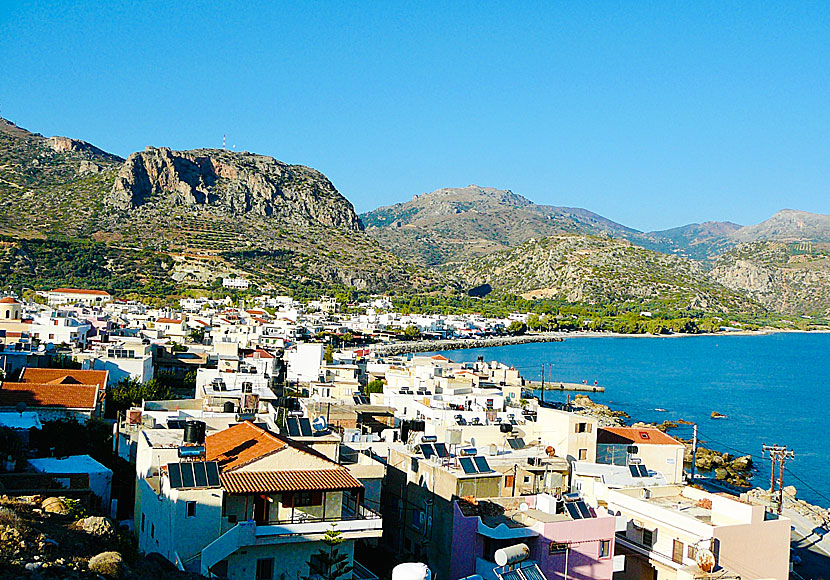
xmin=710 ymin=241 xmax=830 ymax=317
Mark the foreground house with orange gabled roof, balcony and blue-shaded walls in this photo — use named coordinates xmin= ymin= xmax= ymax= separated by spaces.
xmin=135 ymin=422 xmax=382 ymax=580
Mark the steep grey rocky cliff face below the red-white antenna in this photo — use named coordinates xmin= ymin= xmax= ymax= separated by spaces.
xmin=106 ymin=147 xmax=362 ymax=231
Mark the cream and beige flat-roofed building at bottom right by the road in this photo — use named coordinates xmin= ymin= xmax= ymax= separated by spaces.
xmin=600 ymin=484 xmax=790 ymax=580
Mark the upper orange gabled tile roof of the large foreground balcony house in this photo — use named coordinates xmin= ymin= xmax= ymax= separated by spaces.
xmin=205 ymin=421 xmax=288 ymax=471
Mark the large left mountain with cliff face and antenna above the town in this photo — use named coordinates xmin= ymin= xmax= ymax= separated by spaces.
xmin=0 ymin=120 xmax=422 ymax=294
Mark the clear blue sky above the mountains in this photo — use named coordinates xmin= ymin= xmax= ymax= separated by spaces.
xmin=0 ymin=0 xmax=830 ymax=230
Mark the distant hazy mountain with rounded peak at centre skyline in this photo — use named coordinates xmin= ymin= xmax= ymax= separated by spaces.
xmin=360 ymin=185 xmax=639 ymax=265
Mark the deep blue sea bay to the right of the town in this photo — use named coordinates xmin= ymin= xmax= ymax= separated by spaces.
xmin=428 ymin=332 xmax=830 ymax=507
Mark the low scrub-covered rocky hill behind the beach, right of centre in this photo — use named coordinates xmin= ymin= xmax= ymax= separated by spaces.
xmin=450 ymin=234 xmax=760 ymax=312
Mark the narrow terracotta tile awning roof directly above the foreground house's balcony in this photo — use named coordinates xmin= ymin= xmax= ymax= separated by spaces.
xmin=219 ymin=467 xmax=363 ymax=493
